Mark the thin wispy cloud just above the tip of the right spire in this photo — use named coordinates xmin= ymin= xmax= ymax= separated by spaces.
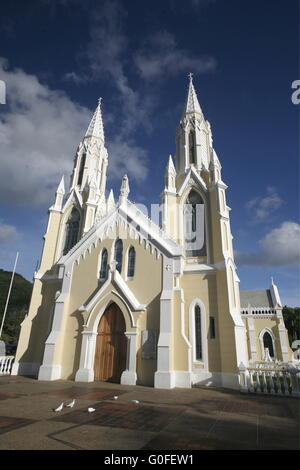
xmin=135 ymin=31 xmax=217 ymax=80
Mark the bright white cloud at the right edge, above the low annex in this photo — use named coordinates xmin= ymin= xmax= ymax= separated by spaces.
xmin=235 ymin=221 xmax=300 ymax=266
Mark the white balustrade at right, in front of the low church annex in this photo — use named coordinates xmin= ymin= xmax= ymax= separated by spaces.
xmin=239 ymin=362 xmax=300 ymax=397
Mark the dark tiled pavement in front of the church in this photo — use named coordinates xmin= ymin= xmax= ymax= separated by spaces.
xmin=0 ymin=376 xmax=299 ymax=451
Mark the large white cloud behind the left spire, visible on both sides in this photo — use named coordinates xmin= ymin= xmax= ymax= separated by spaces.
xmin=0 ymin=59 xmax=147 ymax=206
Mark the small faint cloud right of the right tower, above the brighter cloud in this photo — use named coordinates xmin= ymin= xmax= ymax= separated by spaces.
xmin=245 ymin=186 xmax=284 ymax=224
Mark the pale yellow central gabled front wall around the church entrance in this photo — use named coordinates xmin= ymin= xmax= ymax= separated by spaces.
xmin=52 ymin=222 xmax=162 ymax=385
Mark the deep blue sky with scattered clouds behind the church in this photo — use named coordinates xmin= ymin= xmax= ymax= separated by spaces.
xmin=0 ymin=0 xmax=300 ymax=306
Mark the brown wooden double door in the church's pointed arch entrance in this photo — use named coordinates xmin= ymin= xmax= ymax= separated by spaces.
xmin=94 ymin=303 xmax=127 ymax=383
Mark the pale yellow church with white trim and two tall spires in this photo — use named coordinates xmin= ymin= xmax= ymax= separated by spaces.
xmin=12 ymin=74 xmax=292 ymax=389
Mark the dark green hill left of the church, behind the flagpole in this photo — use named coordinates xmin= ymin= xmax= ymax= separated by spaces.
xmin=0 ymin=269 xmax=32 ymax=344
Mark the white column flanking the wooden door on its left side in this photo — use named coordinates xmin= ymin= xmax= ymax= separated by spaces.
xmin=75 ymin=331 xmax=97 ymax=382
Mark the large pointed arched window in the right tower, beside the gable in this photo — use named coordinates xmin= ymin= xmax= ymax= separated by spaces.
xmin=184 ymin=190 xmax=205 ymax=256
